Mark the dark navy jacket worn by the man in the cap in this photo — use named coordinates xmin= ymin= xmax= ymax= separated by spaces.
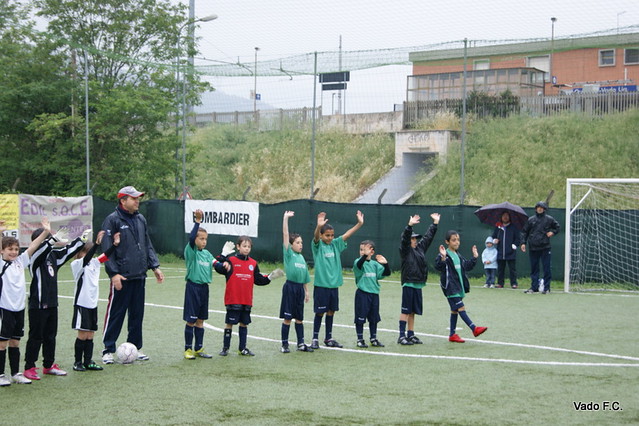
xmin=102 ymin=207 xmax=160 ymax=279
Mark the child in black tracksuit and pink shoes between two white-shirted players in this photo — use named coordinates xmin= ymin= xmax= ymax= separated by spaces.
xmin=24 ymin=228 xmax=91 ymax=380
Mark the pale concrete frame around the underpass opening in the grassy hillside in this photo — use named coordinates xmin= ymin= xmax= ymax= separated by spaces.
xmin=395 ymin=130 xmax=459 ymax=167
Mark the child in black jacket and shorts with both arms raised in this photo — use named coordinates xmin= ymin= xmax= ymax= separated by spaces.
xmin=397 ymin=213 xmax=440 ymax=345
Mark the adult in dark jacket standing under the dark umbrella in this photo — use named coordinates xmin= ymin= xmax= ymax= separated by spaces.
xmin=492 ymin=211 xmax=520 ymax=288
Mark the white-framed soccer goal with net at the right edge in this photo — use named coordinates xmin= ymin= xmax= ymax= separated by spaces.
xmin=564 ymin=179 xmax=639 ymax=291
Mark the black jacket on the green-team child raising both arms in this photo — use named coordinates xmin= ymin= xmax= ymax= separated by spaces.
xmin=399 ymin=223 xmax=437 ymax=284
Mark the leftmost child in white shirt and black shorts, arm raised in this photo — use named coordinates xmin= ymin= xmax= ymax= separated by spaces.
xmin=0 ymin=217 xmax=51 ymax=386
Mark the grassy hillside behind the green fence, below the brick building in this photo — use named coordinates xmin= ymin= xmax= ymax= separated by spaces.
xmin=189 ymin=110 xmax=639 ymax=206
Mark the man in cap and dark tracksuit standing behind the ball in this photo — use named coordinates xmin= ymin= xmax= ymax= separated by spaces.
xmin=102 ymin=186 xmax=164 ymax=364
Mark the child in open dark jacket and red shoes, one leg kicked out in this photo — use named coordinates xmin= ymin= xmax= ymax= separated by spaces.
xmin=435 ymin=230 xmax=488 ymax=343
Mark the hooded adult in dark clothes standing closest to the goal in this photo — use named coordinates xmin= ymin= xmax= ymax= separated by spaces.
xmin=521 ymin=201 xmax=559 ymax=294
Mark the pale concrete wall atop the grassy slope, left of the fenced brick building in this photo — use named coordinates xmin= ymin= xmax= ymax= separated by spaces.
xmin=321 ymin=111 xmax=403 ymax=134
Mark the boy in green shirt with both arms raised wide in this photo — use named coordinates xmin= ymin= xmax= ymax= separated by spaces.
xmin=311 ymin=210 xmax=364 ymax=349
